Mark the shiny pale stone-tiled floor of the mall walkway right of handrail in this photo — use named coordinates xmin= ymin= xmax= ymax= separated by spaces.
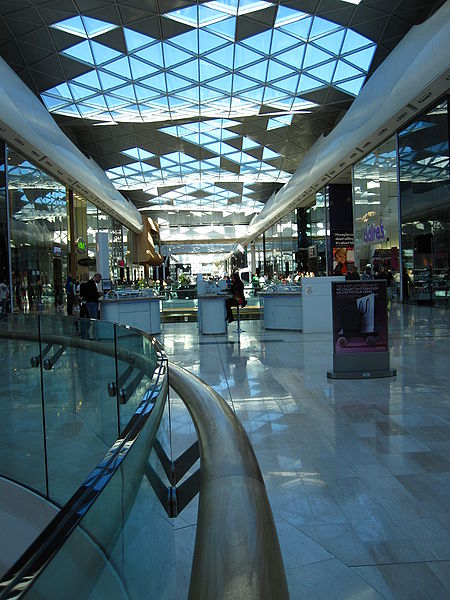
xmin=158 ymin=305 xmax=450 ymax=600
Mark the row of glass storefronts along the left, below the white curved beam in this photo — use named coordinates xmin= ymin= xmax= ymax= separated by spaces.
xmin=0 ymin=142 xmax=133 ymax=311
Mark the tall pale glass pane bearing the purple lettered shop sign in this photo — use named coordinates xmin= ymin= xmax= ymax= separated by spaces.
xmin=353 ymin=136 xmax=400 ymax=280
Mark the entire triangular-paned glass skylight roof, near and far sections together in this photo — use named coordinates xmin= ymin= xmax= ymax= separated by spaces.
xmin=41 ymin=0 xmax=376 ymax=211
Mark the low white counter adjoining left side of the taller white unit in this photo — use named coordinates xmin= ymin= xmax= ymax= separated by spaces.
xmin=259 ymin=290 xmax=303 ymax=331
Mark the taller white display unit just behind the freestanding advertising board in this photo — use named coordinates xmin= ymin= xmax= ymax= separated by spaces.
xmin=301 ymin=276 xmax=345 ymax=333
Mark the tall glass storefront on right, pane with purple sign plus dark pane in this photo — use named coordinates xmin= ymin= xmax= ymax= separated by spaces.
xmin=353 ymin=99 xmax=450 ymax=306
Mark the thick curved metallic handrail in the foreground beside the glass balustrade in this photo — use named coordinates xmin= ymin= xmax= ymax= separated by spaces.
xmin=169 ymin=362 xmax=289 ymax=600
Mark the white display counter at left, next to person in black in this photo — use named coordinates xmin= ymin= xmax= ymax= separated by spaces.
xmin=100 ymin=292 xmax=162 ymax=335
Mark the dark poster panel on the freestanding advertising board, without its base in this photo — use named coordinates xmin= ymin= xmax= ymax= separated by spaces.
xmin=331 ymin=280 xmax=388 ymax=355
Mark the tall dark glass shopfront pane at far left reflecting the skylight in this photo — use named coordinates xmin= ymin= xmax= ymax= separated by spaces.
xmin=7 ymin=148 xmax=68 ymax=310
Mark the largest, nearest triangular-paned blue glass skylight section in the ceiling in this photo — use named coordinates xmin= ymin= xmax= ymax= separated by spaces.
xmin=41 ymin=7 xmax=376 ymax=122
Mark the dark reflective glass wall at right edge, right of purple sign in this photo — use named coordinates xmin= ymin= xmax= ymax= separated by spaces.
xmin=399 ymin=100 xmax=450 ymax=304
